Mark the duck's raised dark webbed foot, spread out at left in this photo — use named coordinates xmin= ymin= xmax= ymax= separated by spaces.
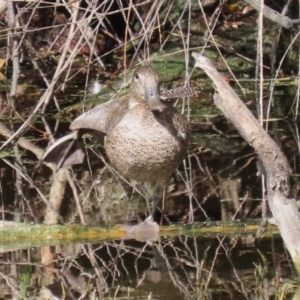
xmin=42 ymin=130 xmax=84 ymax=170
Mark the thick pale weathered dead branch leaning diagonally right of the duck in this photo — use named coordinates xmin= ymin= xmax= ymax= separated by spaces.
xmin=193 ymin=53 xmax=300 ymax=272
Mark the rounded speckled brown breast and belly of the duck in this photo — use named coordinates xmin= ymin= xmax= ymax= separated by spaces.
xmin=105 ymin=103 xmax=187 ymax=181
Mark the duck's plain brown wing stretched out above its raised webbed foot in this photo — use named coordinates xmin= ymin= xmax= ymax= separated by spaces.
xmin=70 ymin=96 xmax=128 ymax=135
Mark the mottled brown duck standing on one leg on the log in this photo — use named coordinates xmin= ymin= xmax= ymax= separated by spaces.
xmin=42 ymin=65 xmax=188 ymax=222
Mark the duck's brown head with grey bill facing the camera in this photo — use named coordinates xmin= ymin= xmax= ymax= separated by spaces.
xmin=131 ymin=66 xmax=166 ymax=111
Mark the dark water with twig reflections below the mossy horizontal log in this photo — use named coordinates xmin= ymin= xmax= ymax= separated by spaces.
xmin=0 ymin=233 xmax=298 ymax=299
